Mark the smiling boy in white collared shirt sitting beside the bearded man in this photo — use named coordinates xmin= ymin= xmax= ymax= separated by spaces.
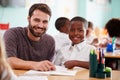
xmin=55 ymin=16 xmax=95 ymax=68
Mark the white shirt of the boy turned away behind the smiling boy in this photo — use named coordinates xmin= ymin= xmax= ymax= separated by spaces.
xmin=53 ymin=32 xmax=71 ymax=52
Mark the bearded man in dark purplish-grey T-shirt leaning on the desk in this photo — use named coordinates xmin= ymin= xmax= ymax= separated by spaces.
xmin=4 ymin=3 xmax=55 ymax=71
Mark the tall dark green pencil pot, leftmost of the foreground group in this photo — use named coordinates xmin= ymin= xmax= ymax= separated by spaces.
xmin=89 ymin=54 xmax=98 ymax=77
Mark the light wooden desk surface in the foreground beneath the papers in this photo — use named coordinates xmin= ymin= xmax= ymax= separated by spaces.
xmin=14 ymin=69 xmax=120 ymax=80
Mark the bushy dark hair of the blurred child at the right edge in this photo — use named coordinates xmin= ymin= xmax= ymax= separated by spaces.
xmin=105 ymin=18 xmax=120 ymax=37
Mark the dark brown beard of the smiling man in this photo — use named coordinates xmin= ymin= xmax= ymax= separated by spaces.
xmin=29 ymin=24 xmax=46 ymax=37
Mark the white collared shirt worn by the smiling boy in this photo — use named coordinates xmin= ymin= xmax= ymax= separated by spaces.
xmin=54 ymin=41 xmax=95 ymax=66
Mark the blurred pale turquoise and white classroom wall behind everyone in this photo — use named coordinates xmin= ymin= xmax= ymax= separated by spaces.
xmin=0 ymin=0 xmax=120 ymax=35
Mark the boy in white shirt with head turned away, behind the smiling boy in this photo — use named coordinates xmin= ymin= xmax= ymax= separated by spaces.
xmin=53 ymin=17 xmax=70 ymax=53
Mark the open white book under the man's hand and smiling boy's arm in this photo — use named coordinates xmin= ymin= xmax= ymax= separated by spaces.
xmin=24 ymin=66 xmax=77 ymax=76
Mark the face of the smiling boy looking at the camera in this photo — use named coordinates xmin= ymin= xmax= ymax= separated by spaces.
xmin=69 ymin=21 xmax=86 ymax=44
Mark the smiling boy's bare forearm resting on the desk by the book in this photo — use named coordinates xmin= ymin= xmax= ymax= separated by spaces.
xmin=64 ymin=60 xmax=89 ymax=69
